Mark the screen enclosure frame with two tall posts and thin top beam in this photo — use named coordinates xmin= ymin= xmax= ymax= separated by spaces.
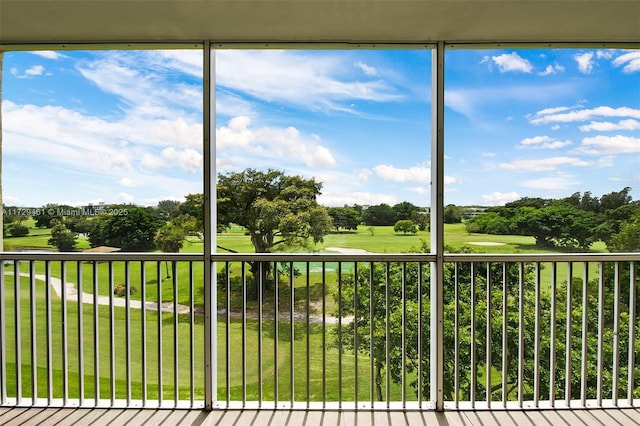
xmin=0 ymin=41 xmax=640 ymax=410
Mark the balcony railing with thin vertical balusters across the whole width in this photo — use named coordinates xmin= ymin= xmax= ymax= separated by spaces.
xmin=0 ymin=253 xmax=640 ymax=409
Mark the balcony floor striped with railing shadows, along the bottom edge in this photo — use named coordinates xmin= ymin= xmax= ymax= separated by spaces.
xmin=0 ymin=408 xmax=640 ymax=426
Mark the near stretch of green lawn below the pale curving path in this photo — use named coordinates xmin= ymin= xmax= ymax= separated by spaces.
xmin=4 ymin=272 xmax=411 ymax=401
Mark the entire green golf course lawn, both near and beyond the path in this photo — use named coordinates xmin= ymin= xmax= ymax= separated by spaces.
xmin=4 ymin=224 xmax=620 ymax=401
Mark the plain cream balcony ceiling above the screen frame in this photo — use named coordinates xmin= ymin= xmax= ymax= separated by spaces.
xmin=0 ymin=0 xmax=640 ymax=48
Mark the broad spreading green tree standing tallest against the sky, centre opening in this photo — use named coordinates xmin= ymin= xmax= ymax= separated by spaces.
xmin=217 ymin=169 xmax=331 ymax=288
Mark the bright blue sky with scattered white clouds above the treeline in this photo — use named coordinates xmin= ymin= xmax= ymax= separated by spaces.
xmin=2 ymin=49 xmax=640 ymax=206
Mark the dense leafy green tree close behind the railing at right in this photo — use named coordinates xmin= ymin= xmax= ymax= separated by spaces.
xmin=333 ymin=248 xmax=640 ymax=401
